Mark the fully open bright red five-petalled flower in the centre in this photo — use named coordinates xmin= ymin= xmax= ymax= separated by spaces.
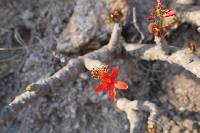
xmin=95 ymin=67 xmax=128 ymax=101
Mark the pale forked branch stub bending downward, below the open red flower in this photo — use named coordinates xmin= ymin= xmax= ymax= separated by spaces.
xmin=116 ymin=98 xmax=159 ymax=133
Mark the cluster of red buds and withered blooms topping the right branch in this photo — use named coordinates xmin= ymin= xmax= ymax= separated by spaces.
xmin=148 ymin=0 xmax=176 ymax=37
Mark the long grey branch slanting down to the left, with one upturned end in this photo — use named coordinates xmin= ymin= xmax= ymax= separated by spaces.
xmin=0 ymin=24 xmax=121 ymax=122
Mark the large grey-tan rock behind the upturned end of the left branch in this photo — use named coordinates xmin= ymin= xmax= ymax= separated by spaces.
xmin=57 ymin=0 xmax=128 ymax=52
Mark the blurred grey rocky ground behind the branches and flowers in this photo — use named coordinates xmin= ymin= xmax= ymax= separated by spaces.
xmin=0 ymin=0 xmax=200 ymax=133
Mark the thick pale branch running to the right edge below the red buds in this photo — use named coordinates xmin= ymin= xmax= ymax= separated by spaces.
xmin=125 ymin=40 xmax=200 ymax=78
